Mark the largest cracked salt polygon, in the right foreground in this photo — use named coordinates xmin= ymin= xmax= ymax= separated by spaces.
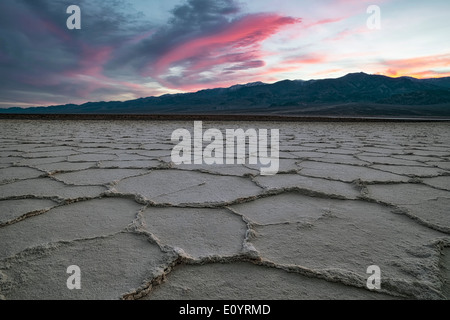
xmin=241 ymin=195 xmax=444 ymax=298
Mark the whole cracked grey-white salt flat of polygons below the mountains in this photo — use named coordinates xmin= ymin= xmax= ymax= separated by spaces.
xmin=0 ymin=120 xmax=450 ymax=300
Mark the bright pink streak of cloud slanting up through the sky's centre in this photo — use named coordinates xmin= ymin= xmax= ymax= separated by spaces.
xmin=145 ymin=14 xmax=300 ymax=88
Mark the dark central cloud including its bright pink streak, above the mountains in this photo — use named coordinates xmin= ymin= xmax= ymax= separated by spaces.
xmin=114 ymin=0 xmax=300 ymax=90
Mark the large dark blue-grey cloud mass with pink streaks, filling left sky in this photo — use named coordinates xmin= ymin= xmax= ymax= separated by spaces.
xmin=0 ymin=0 xmax=299 ymax=107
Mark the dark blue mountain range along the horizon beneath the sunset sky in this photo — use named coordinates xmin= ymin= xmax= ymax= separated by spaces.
xmin=0 ymin=72 xmax=450 ymax=117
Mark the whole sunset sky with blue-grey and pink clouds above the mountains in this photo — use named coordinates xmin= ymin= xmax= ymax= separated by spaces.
xmin=0 ymin=0 xmax=450 ymax=108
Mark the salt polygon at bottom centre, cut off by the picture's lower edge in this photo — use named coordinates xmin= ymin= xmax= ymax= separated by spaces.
xmin=144 ymin=262 xmax=396 ymax=300
